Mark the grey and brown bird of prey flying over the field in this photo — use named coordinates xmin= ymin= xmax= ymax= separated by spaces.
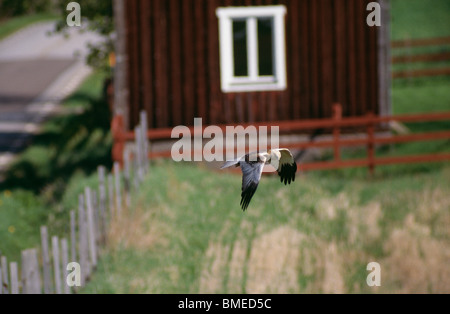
xmin=220 ymin=148 xmax=297 ymax=211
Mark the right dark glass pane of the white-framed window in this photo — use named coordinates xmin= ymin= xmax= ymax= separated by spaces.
xmin=258 ymin=18 xmax=275 ymax=75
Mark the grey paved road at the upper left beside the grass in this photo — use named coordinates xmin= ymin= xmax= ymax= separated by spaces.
xmin=0 ymin=22 xmax=99 ymax=173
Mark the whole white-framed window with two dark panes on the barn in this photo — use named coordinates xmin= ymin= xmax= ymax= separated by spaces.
xmin=216 ymin=5 xmax=286 ymax=92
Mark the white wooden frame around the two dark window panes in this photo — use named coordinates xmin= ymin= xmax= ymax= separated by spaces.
xmin=216 ymin=5 xmax=287 ymax=93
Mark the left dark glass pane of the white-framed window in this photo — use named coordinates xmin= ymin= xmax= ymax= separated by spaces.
xmin=233 ymin=20 xmax=248 ymax=76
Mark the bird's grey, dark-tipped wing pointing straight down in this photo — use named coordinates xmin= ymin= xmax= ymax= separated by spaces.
xmin=239 ymin=158 xmax=264 ymax=211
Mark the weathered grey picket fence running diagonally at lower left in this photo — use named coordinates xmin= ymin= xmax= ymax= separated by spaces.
xmin=0 ymin=113 xmax=149 ymax=294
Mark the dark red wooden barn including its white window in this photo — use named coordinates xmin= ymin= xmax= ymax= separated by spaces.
xmin=115 ymin=0 xmax=390 ymax=129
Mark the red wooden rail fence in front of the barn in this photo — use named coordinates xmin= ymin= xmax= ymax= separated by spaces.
xmin=112 ymin=104 xmax=450 ymax=173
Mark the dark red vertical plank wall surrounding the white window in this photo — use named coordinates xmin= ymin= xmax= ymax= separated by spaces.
xmin=126 ymin=0 xmax=387 ymax=128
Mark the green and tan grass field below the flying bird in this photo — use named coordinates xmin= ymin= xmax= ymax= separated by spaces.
xmin=82 ymin=161 xmax=450 ymax=293
